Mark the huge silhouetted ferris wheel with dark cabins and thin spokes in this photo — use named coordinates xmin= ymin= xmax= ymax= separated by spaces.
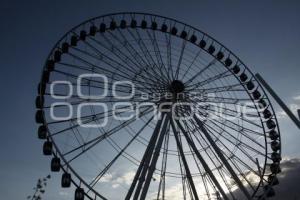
xmin=36 ymin=13 xmax=281 ymax=200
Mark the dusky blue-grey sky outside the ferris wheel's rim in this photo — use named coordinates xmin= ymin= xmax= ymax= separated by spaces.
xmin=0 ymin=0 xmax=300 ymax=200
